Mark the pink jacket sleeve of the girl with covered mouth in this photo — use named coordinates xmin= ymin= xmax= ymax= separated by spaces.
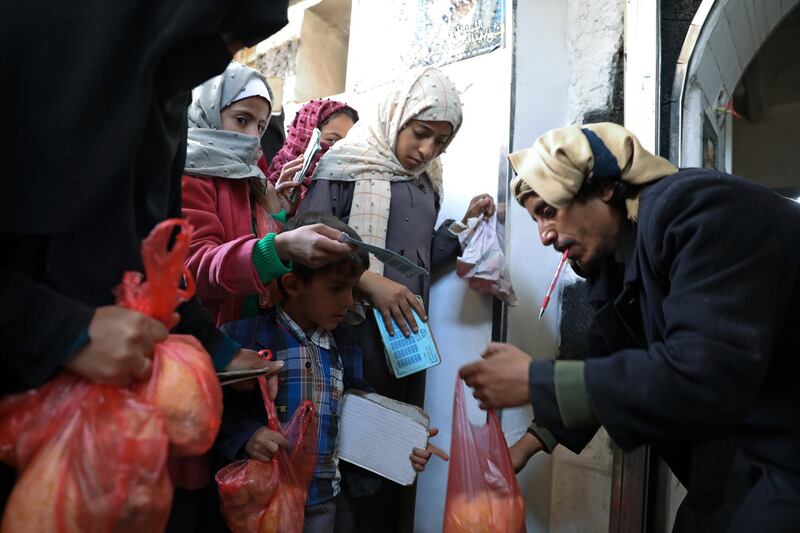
xmin=181 ymin=176 xmax=268 ymax=299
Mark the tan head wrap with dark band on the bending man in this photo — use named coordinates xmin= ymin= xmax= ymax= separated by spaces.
xmin=508 ymin=122 xmax=678 ymax=221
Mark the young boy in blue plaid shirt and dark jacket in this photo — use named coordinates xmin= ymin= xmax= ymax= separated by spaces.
xmin=217 ymin=212 xmax=447 ymax=533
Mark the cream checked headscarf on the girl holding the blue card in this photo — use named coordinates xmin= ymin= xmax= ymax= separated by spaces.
xmin=313 ymin=67 xmax=461 ymax=274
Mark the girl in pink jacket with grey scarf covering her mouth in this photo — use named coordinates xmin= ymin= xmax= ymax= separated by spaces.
xmin=182 ymin=63 xmax=291 ymax=325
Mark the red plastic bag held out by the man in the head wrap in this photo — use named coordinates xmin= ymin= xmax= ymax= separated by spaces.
xmin=444 ymin=378 xmax=525 ymax=533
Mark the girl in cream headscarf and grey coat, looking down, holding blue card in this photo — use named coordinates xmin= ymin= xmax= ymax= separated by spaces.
xmin=300 ymin=68 xmax=494 ymax=405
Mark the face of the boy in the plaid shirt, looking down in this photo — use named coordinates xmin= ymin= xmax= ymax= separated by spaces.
xmin=282 ymin=269 xmax=363 ymax=330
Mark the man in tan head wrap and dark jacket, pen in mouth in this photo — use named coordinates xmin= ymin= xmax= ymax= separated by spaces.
xmin=461 ymin=124 xmax=800 ymax=533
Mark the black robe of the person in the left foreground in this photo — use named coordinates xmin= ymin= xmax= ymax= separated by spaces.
xmin=0 ymin=0 xmax=287 ymax=390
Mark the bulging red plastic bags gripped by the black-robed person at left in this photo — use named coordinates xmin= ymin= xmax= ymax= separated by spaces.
xmin=0 ymin=220 xmax=222 ymax=532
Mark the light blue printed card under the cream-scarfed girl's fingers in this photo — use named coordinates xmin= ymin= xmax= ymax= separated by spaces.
xmin=373 ymin=309 xmax=442 ymax=378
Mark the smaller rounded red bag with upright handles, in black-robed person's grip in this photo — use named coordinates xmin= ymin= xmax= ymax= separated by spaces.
xmin=116 ymin=219 xmax=222 ymax=456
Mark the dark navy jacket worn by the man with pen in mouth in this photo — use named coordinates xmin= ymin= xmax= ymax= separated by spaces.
xmin=531 ymin=169 xmax=800 ymax=525
